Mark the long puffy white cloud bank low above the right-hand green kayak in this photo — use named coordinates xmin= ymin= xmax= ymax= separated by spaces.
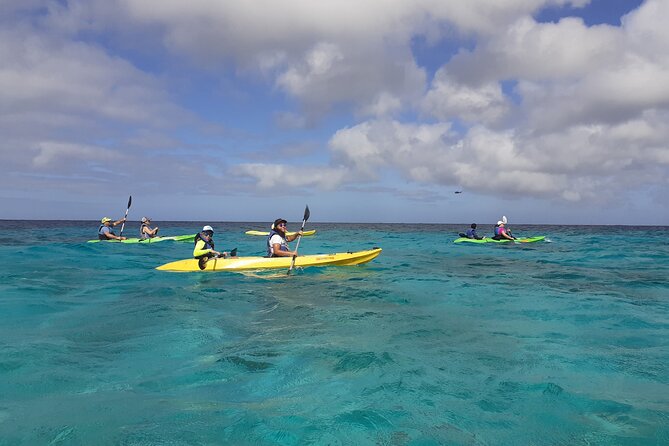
xmin=330 ymin=116 xmax=669 ymax=205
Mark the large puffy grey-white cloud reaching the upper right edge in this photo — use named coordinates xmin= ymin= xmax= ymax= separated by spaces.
xmin=432 ymin=1 xmax=669 ymax=132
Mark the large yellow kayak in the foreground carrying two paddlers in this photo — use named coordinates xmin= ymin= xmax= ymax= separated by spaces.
xmin=156 ymin=248 xmax=381 ymax=272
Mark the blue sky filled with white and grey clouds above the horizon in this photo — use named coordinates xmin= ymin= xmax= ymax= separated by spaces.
xmin=0 ymin=0 xmax=669 ymax=225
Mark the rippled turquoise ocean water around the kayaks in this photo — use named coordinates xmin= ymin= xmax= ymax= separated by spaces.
xmin=0 ymin=221 xmax=669 ymax=446
